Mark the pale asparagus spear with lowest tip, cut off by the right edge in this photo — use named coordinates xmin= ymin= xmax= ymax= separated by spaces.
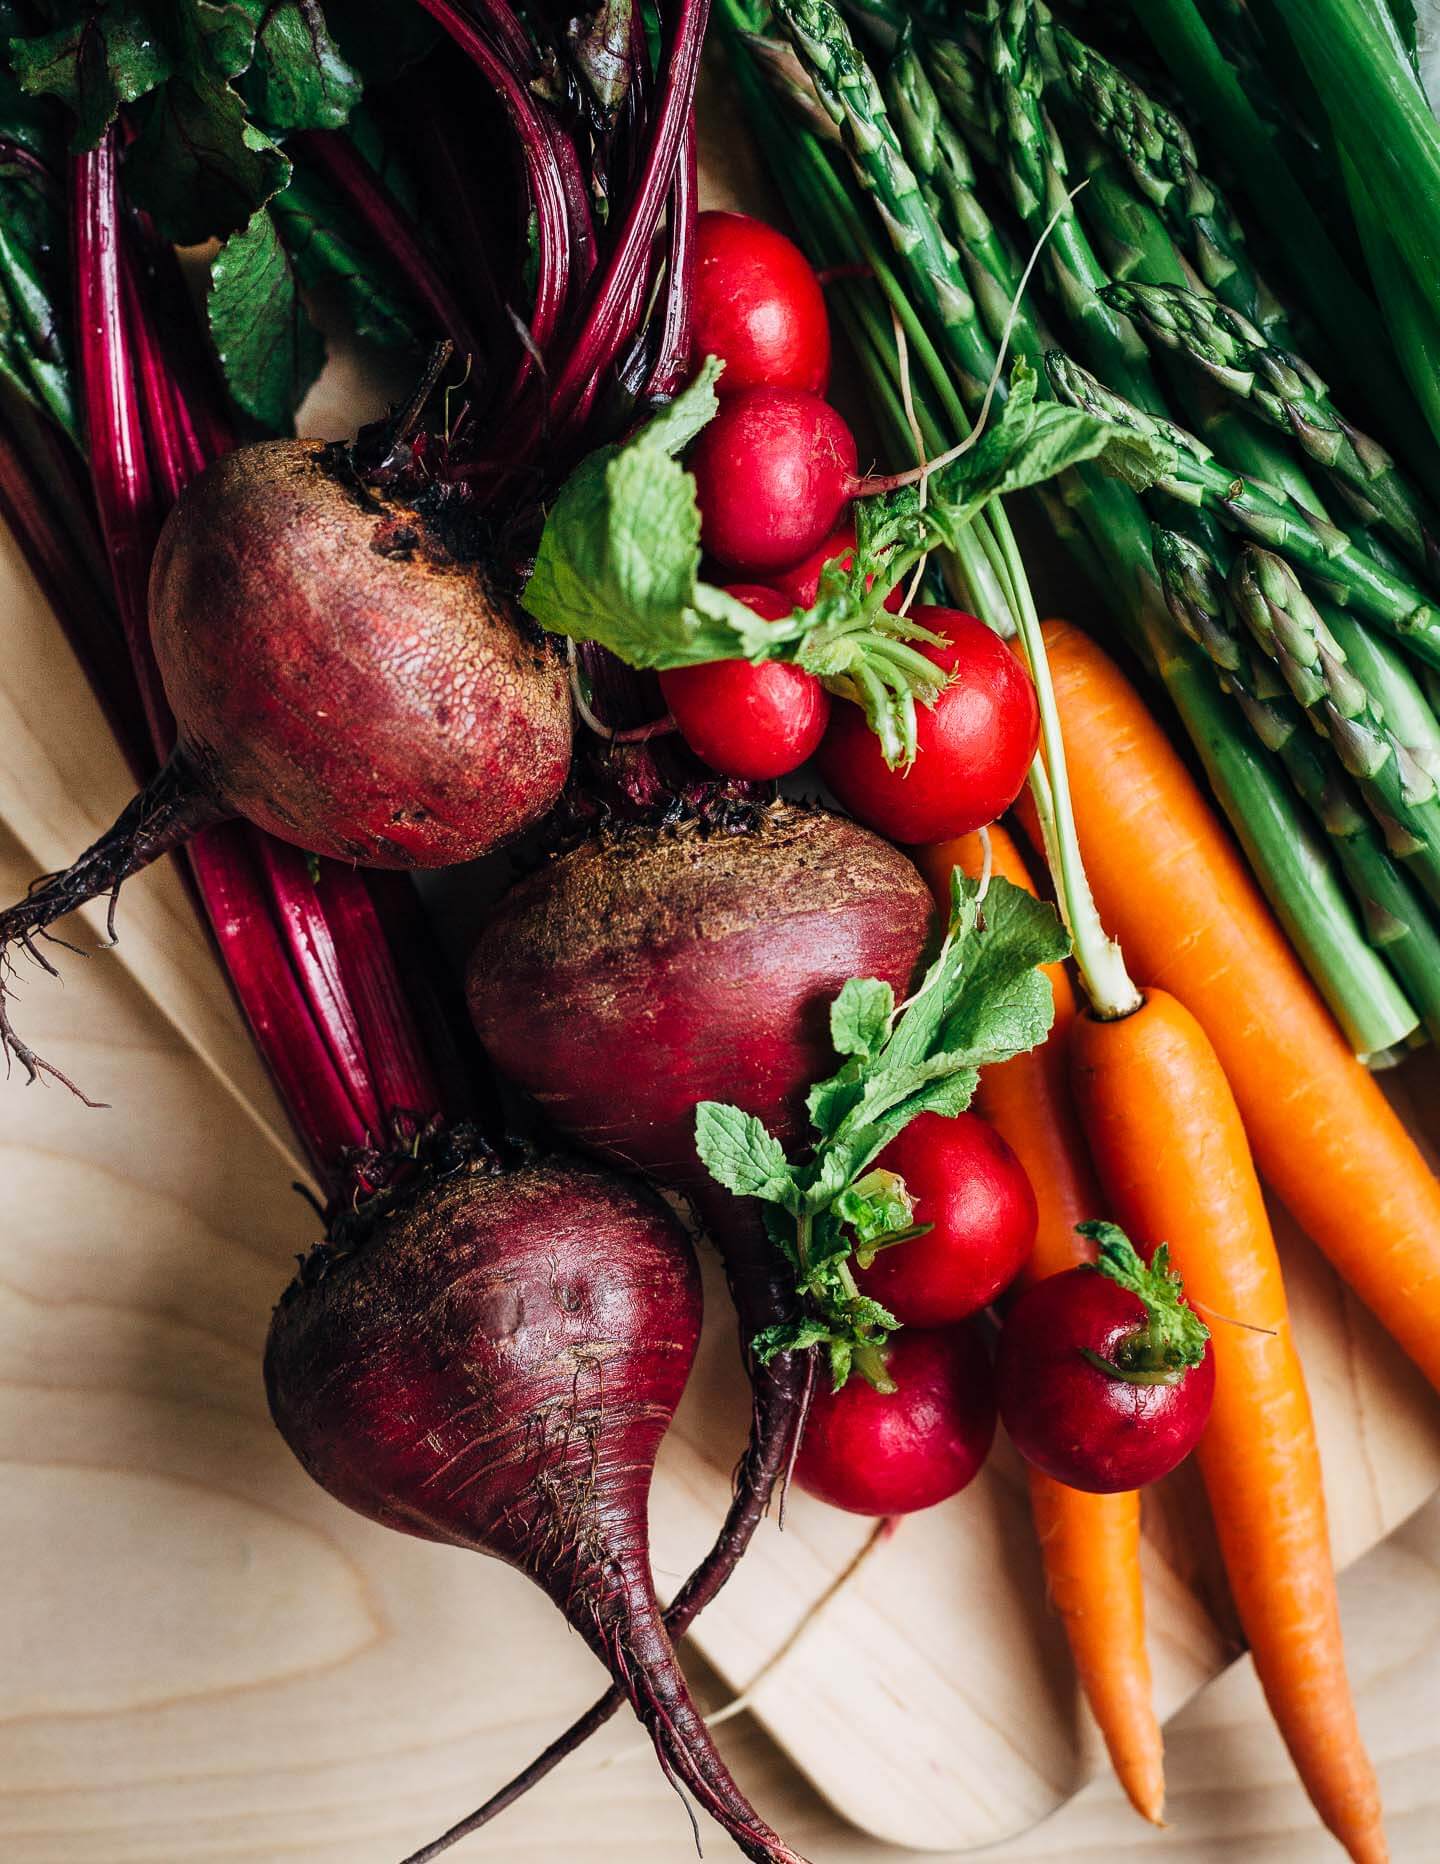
xmin=1229 ymin=544 xmax=1440 ymax=900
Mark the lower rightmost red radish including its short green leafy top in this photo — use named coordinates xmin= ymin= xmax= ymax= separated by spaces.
xmin=997 ymin=1223 xmax=1215 ymax=1495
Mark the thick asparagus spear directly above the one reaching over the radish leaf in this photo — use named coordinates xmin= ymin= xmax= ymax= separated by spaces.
xmin=1105 ymin=283 xmax=1440 ymax=580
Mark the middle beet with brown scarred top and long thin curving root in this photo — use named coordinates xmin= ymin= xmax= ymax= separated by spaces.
xmin=448 ymin=803 xmax=931 ymax=1834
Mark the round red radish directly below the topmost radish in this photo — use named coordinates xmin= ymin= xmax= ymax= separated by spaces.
xmin=687 ymin=388 xmax=857 ymax=578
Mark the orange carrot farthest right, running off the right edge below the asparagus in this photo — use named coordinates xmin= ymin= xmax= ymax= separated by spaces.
xmin=1025 ymin=623 xmax=1440 ymax=1387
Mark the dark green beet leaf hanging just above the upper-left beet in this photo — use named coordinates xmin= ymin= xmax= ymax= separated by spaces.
xmin=205 ymin=207 xmax=322 ymax=431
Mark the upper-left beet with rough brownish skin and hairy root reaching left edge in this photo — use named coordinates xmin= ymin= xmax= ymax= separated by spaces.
xmin=0 ymin=440 xmax=570 ymax=1079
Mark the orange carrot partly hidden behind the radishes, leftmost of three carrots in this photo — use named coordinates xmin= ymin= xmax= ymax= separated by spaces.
xmin=915 ymin=828 xmax=1164 ymax=1825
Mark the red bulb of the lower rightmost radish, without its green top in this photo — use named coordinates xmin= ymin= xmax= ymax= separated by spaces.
xmin=997 ymin=1266 xmax=1215 ymax=1495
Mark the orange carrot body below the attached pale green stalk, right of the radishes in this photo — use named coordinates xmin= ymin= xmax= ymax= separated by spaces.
xmin=1071 ymin=991 xmax=1388 ymax=1864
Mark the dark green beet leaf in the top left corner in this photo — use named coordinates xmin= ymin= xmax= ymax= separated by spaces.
xmin=9 ymin=0 xmax=173 ymax=151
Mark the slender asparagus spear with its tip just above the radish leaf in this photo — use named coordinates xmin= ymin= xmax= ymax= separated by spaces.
xmin=1045 ymin=350 xmax=1440 ymax=667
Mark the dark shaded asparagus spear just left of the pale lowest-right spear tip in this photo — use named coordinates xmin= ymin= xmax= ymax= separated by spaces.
xmin=1155 ymin=526 xmax=1440 ymax=1040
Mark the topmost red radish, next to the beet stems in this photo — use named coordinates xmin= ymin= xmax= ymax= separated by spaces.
xmin=691 ymin=211 xmax=831 ymax=397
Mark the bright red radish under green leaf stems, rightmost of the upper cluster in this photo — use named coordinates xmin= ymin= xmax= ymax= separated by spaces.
xmin=820 ymin=606 xmax=1039 ymax=844
